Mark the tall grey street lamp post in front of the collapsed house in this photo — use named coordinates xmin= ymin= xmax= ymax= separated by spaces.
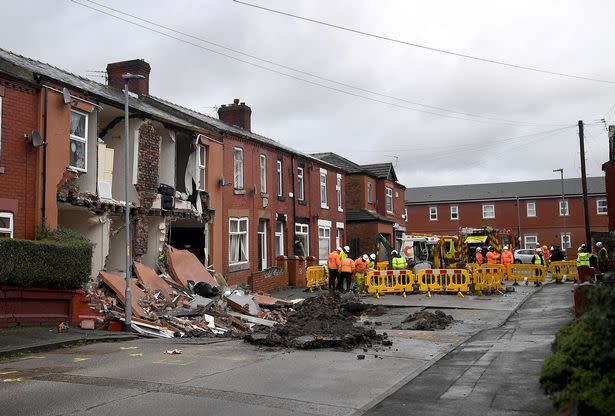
xmin=122 ymin=73 xmax=145 ymax=332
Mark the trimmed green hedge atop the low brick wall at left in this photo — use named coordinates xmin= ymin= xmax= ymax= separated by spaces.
xmin=0 ymin=229 xmax=93 ymax=288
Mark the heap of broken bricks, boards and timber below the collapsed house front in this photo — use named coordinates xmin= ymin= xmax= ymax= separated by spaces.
xmin=84 ymin=248 xmax=300 ymax=338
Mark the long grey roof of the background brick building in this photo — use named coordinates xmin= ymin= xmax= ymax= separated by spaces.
xmin=405 ymin=176 xmax=606 ymax=204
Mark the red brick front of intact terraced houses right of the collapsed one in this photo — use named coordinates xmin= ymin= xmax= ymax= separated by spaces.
xmin=222 ymin=135 xmax=345 ymax=284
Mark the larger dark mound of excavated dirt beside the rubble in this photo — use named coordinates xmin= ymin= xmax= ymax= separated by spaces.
xmin=244 ymin=293 xmax=388 ymax=349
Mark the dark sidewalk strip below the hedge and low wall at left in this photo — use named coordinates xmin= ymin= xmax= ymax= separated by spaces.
xmin=0 ymin=326 xmax=139 ymax=358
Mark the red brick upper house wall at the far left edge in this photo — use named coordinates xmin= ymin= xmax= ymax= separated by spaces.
xmin=0 ymin=79 xmax=42 ymax=239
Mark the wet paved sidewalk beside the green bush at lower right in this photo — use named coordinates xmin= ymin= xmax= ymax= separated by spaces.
xmin=359 ymin=285 xmax=572 ymax=416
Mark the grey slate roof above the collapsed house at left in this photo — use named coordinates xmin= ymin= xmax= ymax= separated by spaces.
xmin=0 ymin=49 xmax=201 ymax=131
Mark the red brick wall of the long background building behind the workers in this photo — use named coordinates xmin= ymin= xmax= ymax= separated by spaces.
xmin=406 ymin=196 xmax=608 ymax=257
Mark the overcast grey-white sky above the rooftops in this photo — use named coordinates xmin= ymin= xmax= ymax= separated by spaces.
xmin=0 ymin=0 xmax=615 ymax=187
